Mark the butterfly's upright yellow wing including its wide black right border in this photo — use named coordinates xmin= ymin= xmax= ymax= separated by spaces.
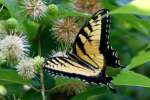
xmin=73 ymin=9 xmax=122 ymax=71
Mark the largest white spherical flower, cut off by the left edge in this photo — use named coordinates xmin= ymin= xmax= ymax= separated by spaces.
xmin=0 ymin=35 xmax=29 ymax=62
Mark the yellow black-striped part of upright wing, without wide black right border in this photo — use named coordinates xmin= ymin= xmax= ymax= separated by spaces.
xmin=73 ymin=10 xmax=110 ymax=71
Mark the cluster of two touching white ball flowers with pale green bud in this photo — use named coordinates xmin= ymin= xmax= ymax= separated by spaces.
xmin=0 ymin=32 xmax=44 ymax=79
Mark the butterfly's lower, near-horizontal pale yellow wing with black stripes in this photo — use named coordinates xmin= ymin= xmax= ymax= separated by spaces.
xmin=44 ymin=56 xmax=99 ymax=78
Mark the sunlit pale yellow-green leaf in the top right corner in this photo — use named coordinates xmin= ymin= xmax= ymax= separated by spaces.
xmin=111 ymin=0 xmax=150 ymax=16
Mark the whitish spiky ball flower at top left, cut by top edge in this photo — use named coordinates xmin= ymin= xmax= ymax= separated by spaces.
xmin=24 ymin=0 xmax=47 ymax=19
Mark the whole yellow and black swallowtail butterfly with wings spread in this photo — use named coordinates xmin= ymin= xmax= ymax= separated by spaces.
xmin=43 ymin=9 xmax=122 ymax=90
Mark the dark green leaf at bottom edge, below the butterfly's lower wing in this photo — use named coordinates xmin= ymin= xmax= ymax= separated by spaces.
xmin=71 ymin=87 xmax=106 ymax=100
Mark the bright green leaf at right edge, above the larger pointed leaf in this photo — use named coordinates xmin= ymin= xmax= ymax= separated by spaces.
xmin=127 ymin=50 xmax=150 ymax=69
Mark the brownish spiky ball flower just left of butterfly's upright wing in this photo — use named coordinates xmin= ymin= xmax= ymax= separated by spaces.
xmin=52 ymin=17 xmax=79 ymax=43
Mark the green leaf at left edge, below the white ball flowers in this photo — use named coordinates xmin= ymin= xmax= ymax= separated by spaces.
xmin=0 ymin=68 xmax=29 ymax=84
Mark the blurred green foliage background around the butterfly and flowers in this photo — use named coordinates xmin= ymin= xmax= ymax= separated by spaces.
xmin=0 ymin=0 xmax=150 ymax=100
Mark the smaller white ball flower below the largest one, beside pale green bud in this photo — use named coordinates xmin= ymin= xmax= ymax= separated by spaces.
xmin=16 ymin=58 xmax=36 ymax=79
